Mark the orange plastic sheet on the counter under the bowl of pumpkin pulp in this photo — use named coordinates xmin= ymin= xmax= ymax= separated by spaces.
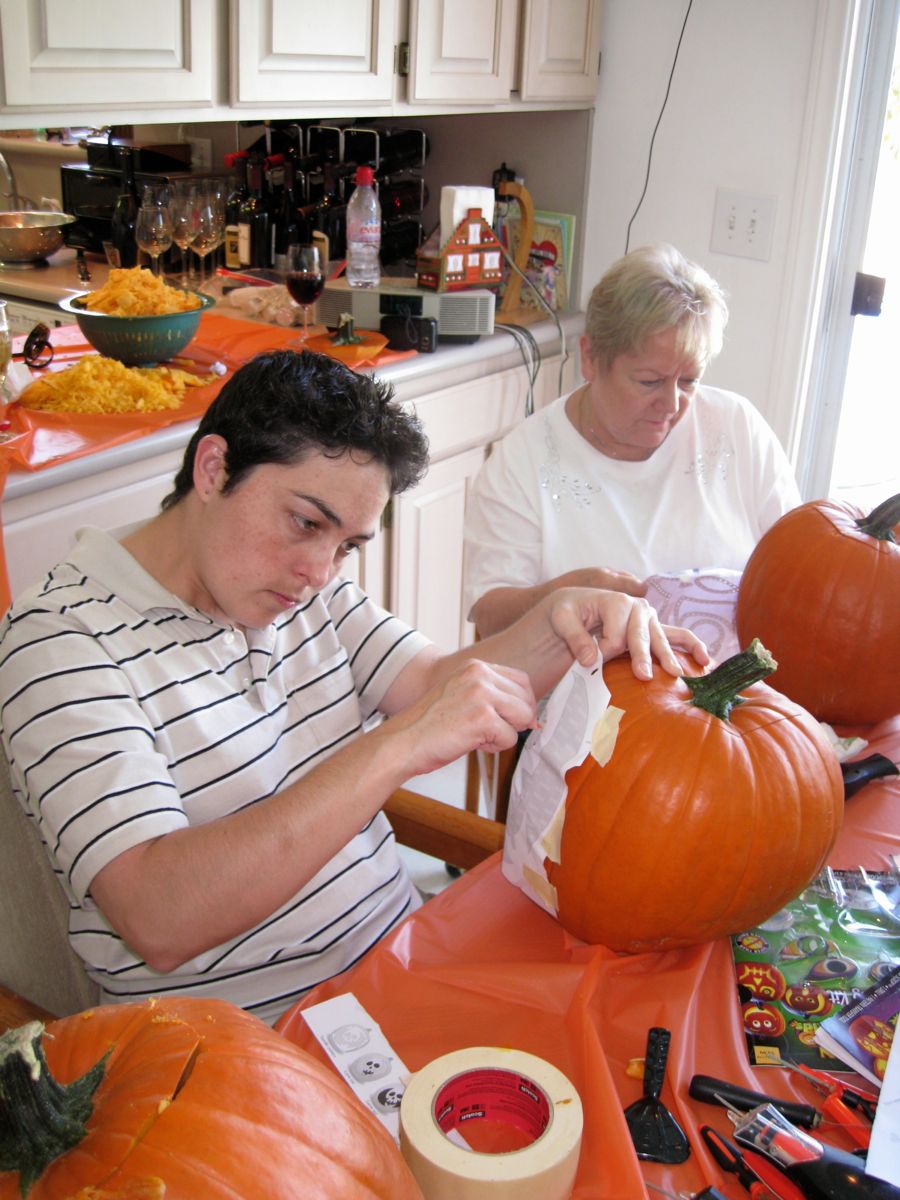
xmin=0 ymin=312 xmax=415 ymax=614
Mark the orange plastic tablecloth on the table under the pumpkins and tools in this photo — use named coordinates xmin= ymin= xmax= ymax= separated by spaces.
xmin=278 ymin=718 xmax=900 ymax=1200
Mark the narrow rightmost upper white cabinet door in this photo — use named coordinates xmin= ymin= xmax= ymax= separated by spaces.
xmin=520 ymin=0 xmax=601 ymax=101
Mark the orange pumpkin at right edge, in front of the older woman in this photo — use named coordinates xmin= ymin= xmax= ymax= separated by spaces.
xmin=736 ymin=496 xmax=900 ymax=725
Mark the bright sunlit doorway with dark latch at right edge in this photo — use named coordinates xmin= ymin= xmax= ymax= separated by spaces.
xmin=798 ymin=0 xmax=900 ymax=511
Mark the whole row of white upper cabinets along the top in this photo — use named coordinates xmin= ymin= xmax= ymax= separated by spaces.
xmin=0 ymin=0 xmax=601 ymax=126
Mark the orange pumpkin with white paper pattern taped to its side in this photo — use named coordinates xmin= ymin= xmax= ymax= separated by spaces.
xmin=545 ymin=642 xmax=844 ymax=953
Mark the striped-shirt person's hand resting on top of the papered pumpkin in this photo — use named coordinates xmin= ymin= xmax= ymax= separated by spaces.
xmin=547 ymin=588 xmax=709 ymax=679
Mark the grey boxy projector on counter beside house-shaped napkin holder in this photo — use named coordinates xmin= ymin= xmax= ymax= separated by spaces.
xmin=317 ymin=278 xmax=496 ymax=342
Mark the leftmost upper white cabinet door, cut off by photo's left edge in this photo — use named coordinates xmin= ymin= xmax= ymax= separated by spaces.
xmin=0 ymin=0 xmax=215 ymax=110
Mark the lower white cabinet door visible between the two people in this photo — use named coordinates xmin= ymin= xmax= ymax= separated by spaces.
xmin=390 ymin=446 xmax=485 ymax=650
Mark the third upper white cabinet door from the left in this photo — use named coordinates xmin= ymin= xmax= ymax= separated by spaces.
xmin=409 ymin=0 xmax=518 ymax=104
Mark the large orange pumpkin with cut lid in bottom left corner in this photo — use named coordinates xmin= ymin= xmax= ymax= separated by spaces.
xmin=0 ymin=998 xmax=421 ymax=1200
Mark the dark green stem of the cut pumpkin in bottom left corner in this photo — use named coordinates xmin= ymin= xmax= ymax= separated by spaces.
xmin=0 ymin=1021 xmax=107 ymax=1198
